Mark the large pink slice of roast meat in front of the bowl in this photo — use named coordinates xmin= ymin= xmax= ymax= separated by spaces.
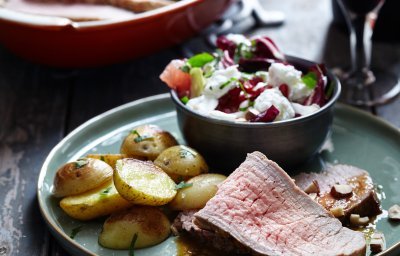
xmin=194 ymin=152 xmax=366 ymax=255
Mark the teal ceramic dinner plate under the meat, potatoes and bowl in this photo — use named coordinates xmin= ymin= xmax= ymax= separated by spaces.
xmin=38 ymin=94 xmax=400 ymax=256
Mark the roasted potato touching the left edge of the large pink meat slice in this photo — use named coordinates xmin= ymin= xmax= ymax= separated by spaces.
xmin=169 ymin=173 xmax=226 ymax=210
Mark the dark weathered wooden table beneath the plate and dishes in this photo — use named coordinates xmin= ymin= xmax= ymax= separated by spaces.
xmin=0 ymin=0 xmax=400 ymax=256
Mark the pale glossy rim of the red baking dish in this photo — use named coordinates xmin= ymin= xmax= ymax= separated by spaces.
xmin=0 ymin=0 xmax=202 ymax=31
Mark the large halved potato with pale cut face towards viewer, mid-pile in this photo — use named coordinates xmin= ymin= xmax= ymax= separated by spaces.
xmin=114 ymin=158 xmax=176 ymax=206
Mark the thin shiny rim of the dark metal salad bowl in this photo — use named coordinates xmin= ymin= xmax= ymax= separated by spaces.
xmin=170 ymin=55 xmax=342 ymax=128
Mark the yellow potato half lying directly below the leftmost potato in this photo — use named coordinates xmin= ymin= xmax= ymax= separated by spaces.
xmin=60 ymin=180 xmax=132 ymax=220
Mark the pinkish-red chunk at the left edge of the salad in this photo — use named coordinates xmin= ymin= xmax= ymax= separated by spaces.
xmin=160 ymin=60 xmax=191 ymax=97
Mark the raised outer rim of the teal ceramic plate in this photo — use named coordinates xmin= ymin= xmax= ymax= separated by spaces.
xmin=36 ymin=93 xmax=400 ymax=256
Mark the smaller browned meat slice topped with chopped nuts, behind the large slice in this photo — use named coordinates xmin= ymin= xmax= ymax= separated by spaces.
xmin=294 ymin=165 xmax=381 ymax=224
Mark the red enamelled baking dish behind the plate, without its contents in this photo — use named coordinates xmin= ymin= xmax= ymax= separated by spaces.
xmin=0 ymin=0 xmax=234 ymax=67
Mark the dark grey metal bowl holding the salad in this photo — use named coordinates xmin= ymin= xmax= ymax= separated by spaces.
xmin=171 ymin=56 xmax=341 ymax=174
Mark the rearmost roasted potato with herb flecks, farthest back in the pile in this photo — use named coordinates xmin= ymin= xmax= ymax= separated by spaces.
xmin=121 ymin=125 xmax=178 ymax=161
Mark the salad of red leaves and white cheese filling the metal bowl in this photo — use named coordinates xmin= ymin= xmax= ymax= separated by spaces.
xmin=160 ymin=34 xmax=333 ymax=122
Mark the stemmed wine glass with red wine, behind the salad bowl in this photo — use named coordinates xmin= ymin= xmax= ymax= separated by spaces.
xmin=337 ymin=0 xmax=400 ymax=106
